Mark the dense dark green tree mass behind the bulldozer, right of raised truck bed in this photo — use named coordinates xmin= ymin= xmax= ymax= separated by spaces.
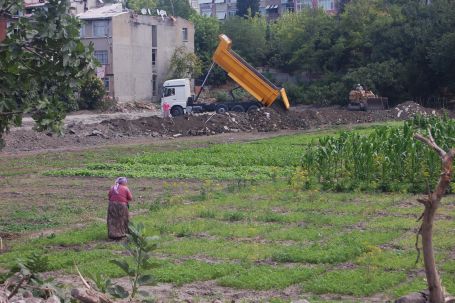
xmin=256 ymin=0 xmax=455 ymax=103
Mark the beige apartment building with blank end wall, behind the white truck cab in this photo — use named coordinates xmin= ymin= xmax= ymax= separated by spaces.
xmin=77 ymin=3 xmax=194 ymax=102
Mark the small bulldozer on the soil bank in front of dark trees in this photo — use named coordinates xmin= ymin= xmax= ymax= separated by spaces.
xmin=348 ymin=84 xmax=389 ymax=111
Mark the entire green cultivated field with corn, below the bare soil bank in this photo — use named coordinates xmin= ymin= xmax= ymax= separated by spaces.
xmin=0 ymin=118 xmax=455 ymax=302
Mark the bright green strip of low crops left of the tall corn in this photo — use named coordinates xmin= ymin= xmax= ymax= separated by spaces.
xmin=47 ymin=135 xmax=316 ymax=180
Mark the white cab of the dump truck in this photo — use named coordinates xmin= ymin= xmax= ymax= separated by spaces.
xmin=161 ymin=79 xmax=192 ymax=117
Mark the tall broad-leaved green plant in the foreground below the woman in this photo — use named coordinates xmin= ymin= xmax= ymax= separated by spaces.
xmin=108 ymin=223 xmax=159 ymax=300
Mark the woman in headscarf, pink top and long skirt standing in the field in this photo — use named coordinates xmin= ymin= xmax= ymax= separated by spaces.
xmin=107 ymin=177 xmax=133 ymax=240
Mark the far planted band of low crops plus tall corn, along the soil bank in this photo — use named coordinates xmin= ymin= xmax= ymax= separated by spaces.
xmin=47 ymin=117 xmax=455 ymax=192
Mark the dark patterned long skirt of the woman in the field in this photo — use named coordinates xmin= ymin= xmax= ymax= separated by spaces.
xmin=107 ymin=201 xmax=128 ymax=240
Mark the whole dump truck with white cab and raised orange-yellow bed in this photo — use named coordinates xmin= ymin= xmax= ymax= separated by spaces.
xmin=161 ymin=34 xmax=290 ymax=117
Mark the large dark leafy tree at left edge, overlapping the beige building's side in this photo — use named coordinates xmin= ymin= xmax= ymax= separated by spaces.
xmin=0 ymin=0 xmax=95 ymax=148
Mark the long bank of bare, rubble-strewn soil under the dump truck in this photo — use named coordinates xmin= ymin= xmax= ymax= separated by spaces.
xmin=2 ymin=101 xmax=455 ymax=153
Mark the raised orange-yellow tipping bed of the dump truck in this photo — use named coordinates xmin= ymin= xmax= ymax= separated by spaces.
xmin=213 ymin=34 xmax=290 ymax=109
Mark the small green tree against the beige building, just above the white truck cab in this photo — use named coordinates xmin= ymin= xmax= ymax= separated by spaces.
xmin=169 ymin=46 xmax=202 ymax=79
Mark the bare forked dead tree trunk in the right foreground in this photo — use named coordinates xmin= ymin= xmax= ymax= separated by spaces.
xmin=414 ymin=130 xmax=455 ymax=303
